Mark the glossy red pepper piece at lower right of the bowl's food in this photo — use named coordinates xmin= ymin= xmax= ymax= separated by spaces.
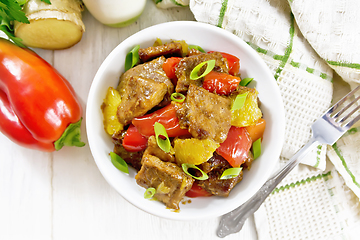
xmin=216 ymin=126 xmax=252 ymax=167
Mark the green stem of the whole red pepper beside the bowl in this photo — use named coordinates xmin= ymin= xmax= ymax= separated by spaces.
xmin=54 ymin=118 xmax=85 ymax=151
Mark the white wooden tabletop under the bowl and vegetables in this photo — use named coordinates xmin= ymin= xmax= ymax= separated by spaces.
xmin=0 ymin=0 xmax=257 ymax=240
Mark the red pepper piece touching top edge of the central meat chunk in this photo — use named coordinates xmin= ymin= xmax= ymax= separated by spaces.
xmin=203 ymin=71 xmax=241 ymax=95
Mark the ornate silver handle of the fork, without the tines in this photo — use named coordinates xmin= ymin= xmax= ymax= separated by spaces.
xmin=217 ymin=138 xmax=318 ymax=237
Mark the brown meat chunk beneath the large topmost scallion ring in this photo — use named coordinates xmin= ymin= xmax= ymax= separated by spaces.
xmin=175 ymin=52 xmax=229 ymax=92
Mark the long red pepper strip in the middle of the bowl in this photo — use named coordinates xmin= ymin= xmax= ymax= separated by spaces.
xmin=132 ymin=104 xmax=190 ymax=137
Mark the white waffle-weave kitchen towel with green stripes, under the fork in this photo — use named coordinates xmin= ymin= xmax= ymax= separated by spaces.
xmin=190 ymin=0 xmax=360 ymax=239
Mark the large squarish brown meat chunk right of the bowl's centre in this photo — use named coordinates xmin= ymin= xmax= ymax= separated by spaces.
xmin=176 ymin=84 xmax=231 ymax=143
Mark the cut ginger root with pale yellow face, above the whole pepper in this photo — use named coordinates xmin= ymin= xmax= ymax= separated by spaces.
xmin=14 ymin=0 xmax=85 ymax=50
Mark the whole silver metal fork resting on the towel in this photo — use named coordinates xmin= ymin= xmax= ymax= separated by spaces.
xmin=217 ymin=85 xmax=360 ymax=237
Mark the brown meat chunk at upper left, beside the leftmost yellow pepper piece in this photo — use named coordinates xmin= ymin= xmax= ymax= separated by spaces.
xmin=117 ymin=76 xmax=167 ymax=126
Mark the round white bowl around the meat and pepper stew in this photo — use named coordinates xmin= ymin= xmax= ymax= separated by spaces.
xmin=86 ymin=21 xmax=285 ymax=220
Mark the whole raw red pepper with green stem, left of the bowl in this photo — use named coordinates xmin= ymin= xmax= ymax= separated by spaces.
xmin=0 ymin=39 xmax=85 ymax=152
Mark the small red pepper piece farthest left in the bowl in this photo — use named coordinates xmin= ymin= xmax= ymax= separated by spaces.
xmin=122 ymin=124 xmax=147 ymax=152
